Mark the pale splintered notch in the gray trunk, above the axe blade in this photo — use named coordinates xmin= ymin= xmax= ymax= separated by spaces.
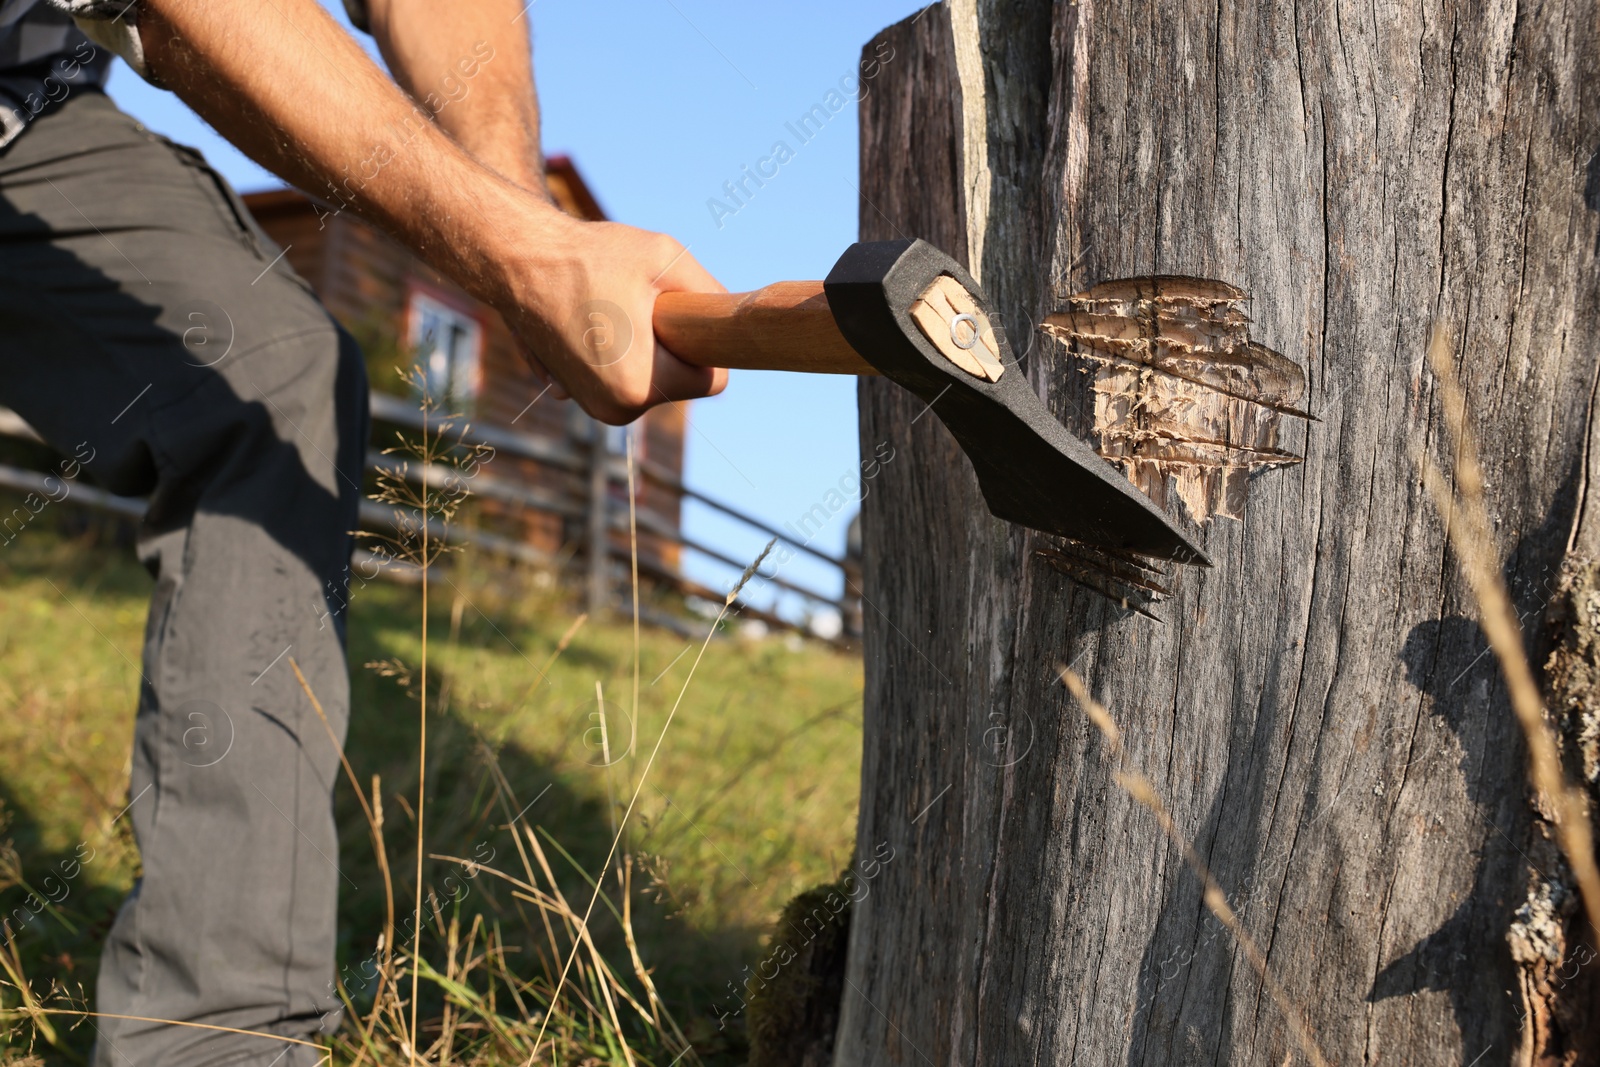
xmin=1043 ymin=275 xmax=1310 ymax=523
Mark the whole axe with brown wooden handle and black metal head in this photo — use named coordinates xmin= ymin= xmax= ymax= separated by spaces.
xmin=654 ymin=240 xmax=1210 ymax=566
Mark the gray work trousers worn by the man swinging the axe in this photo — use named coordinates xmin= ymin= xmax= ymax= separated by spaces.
xmin=0 ymin=90 xmax=368 ymax=1067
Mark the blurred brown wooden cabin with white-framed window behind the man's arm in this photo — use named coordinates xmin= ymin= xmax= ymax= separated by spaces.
xmin=245 ymin=155 xmax=685 ymax=577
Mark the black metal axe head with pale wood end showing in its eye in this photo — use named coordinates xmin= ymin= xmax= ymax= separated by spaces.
xmin=822 ymin=240 xmax=1211 ymax=566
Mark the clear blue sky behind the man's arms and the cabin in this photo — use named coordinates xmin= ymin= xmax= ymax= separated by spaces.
xmin=110 ymin=0 xmax=922 ymax=613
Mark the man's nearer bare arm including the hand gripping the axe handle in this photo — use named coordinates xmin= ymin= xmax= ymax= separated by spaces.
xmin=139 ymin=0 xmax=726 ymax=422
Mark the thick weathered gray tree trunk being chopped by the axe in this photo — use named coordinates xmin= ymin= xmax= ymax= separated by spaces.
xmin=835 ymin=0 xmax=1600 ymax=1067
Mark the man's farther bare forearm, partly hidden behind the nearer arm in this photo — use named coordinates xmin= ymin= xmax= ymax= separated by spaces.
xmin=368 ymin=0 xmax=544 ymax=195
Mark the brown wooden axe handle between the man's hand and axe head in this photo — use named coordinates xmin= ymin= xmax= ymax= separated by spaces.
xmin=654 ymin=282 xmax=877 ymax=374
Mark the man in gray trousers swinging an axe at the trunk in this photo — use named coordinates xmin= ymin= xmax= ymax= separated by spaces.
xmin=0 ymin=0 xmax=726 ymax=1067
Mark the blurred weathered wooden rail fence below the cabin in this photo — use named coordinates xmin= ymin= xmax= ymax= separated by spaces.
xmin=0 ymin=394 xmax=853 ymax=639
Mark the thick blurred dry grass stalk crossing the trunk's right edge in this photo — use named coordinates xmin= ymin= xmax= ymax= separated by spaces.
xmin=1418 ymin=326 xmax=1600 ymax=934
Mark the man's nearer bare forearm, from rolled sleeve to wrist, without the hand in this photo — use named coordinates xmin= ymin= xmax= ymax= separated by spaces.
xmin=139 ymin=0 xmax=560 ymax=313
